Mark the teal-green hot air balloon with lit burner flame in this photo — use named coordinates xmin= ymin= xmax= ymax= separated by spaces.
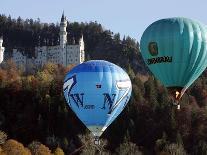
xmin=140 ymin=17 xmax=207 ymax=106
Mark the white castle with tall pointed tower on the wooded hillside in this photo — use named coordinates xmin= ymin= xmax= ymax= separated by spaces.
xmin=0 ymin=13 xmax=85 ymax=69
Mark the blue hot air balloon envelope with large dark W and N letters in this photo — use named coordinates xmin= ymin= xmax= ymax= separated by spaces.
xmin=63 ymin=60 xmax=132 ymax=137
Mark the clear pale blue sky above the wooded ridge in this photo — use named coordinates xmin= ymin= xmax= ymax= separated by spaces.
xmin=0 ymin=0 xmax=207 ymax=41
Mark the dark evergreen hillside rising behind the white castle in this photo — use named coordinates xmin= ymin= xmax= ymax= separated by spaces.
xmin=0 ymin=15 xmax=146 ymax=73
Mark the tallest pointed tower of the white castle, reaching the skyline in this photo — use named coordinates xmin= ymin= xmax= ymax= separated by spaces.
xmin=59 ymin=12 xmax=67 ymax=48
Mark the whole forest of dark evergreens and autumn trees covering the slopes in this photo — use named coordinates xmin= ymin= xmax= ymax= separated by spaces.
xmin=0 ymin=15 xmax=207 ymax=155
